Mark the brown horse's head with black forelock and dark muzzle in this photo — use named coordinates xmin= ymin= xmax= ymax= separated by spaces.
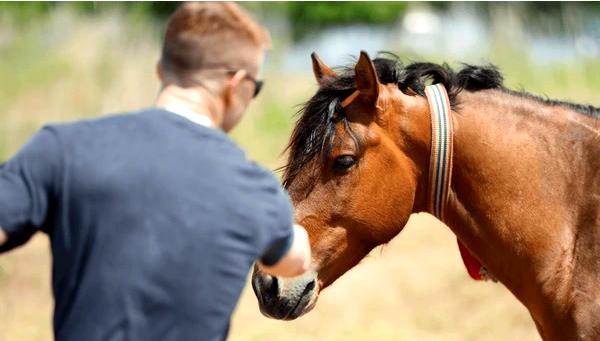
xmin=252 ymin=52 xmax=438 ymax=319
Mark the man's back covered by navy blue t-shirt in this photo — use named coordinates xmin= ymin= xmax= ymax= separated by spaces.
xmin=2 ymin=109 xmax=291 ymax=340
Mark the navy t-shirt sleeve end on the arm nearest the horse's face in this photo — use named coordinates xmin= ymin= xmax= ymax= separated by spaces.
xmin=251 ymin=165 xmax=294 ymax=266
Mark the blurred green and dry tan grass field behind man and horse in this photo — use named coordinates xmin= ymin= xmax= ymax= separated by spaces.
xmin=0 ymin=7 xmax=600 ymax=341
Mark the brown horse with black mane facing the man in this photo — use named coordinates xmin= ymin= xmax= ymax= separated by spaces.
xmin=252 ymin=52 xmax=600 ymax=340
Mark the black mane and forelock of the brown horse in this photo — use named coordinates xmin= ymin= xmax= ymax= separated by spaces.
xmin=282 ymin=52 xmax=600 ymax=188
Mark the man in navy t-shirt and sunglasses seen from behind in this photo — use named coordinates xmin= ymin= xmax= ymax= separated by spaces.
xmin=0 ymin=3 xmax=310 ymax=341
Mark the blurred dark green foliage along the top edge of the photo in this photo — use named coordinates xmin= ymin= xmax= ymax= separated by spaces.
xmin=0 ymin=1 xmax=600 ymax=41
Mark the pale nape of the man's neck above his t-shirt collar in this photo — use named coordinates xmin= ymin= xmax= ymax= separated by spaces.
xmin=156 ymin=85 xmax=224 ymax=128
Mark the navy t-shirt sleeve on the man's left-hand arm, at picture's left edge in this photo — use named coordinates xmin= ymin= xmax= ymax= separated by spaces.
xmin=0 ymin=128 xmax=61 ymax=253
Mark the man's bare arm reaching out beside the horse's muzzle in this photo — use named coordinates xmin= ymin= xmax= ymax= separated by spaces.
xmin=257 ymin=225 xmax=311 ymax=277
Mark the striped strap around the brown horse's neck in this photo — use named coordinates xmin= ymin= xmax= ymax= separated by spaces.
xmin=425 ymin=83 xmax=453 ymax=221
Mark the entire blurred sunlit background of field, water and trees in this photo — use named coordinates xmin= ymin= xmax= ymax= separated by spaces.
xmin=0 ymin=2 xmax=600 ymax=341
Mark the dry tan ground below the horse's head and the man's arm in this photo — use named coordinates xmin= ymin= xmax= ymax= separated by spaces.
xmin=0 ymin=214 xmax=539 ymax=341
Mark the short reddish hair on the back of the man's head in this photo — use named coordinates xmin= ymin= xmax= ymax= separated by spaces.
xmin=160 ymin=2 xmax=271 ymax=80
